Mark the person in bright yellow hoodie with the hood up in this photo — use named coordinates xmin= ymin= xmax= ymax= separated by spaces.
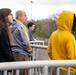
xmin=47 ymin=10 xmax=76 ymax=75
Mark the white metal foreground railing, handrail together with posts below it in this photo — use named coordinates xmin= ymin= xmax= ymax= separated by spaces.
xmin=0 ymin=60 xmax=76 ymax=75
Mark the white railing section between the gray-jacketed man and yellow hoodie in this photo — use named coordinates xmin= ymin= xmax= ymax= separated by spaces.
xmin=31 ymin=42 xmax=47 ymax=75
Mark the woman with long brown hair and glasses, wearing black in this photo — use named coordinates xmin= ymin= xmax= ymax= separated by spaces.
xmin=0 ymin=8 xmax=14 ymax=75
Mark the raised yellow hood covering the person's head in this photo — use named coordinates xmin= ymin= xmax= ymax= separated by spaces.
xmin=56 ymin=11 xmax=74 ymax=32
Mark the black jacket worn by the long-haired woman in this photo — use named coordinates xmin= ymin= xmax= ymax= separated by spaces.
xmin=0 ymin=25 xmax=14 ymax=62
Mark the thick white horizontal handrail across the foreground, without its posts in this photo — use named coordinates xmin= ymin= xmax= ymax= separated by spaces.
xmin=0 ymin=60 xmax=76 ymax=70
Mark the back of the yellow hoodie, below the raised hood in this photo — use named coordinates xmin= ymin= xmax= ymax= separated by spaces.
xmin=50 ymin=30 xmax=75 ymax=60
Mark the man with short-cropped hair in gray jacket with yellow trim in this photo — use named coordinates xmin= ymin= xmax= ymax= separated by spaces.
xmin=10 ymin=10 xmax=32 ymax=75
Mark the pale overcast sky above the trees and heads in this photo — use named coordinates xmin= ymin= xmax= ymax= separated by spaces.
xmin=0 ymin=0 xmax=76 ymax=20
